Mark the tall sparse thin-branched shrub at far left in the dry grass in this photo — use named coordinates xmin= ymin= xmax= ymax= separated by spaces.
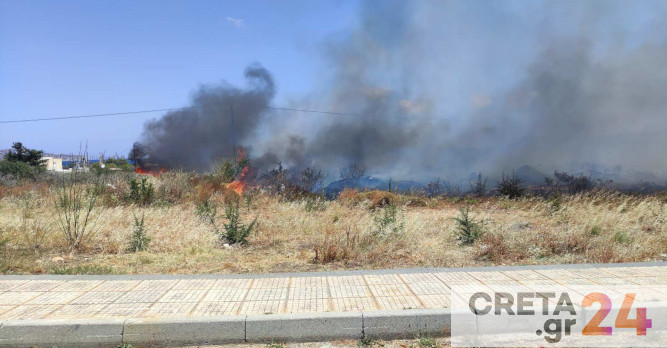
xmin=54 ymin=171 xmax=103 ymax=249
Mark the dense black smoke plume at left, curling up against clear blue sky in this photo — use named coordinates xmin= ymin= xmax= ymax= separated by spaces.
xmin=130 ymin=65 xmax=276 ymax=171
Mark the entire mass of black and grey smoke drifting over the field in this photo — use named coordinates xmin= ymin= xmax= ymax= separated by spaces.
xmin=136 ymin=1 xmax=667 ymax=179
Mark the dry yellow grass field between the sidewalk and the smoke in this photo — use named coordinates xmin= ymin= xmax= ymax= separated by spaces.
xmin=0 ymin=173 xmax=667 ymax=274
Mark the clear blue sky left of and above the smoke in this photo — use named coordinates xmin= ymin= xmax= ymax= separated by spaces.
xmin=0 ymin=0 xmax=358 ymax=155
